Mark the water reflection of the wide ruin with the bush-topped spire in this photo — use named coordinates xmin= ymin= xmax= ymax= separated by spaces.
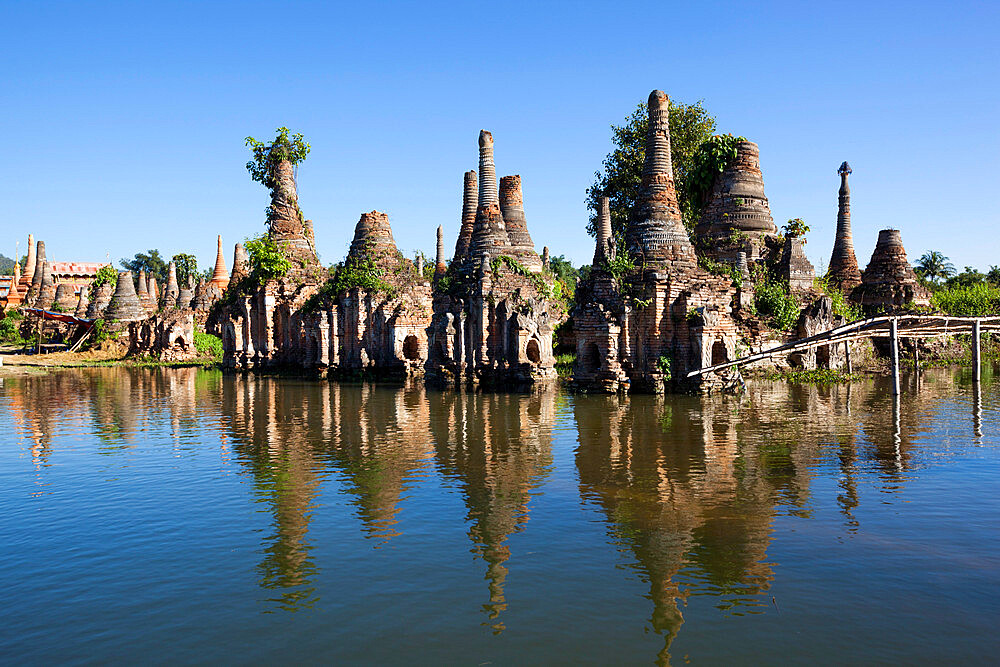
xmin=223 ymin=377 xmax=432 ymax=609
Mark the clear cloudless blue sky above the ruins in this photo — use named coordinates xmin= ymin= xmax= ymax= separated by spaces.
xmin=0 ymin=0 xmax=1000 ymax=276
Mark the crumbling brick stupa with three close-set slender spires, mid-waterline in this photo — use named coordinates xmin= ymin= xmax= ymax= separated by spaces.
xmin=427 ymin=130 xmax=566 ymax=385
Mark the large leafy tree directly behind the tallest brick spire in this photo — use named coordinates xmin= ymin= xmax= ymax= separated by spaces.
xmin=587 ymin=100 xmax=715 ymax=238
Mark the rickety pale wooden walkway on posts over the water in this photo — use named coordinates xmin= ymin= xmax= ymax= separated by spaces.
xmin=687 ymin=315 xmax=1000 ymax=395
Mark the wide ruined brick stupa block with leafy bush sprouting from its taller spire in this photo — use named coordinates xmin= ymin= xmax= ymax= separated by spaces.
xmin=215 ymin=149 xmax=431 ymax=374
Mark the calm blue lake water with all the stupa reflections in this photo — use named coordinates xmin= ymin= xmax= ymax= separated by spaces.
xmin=0 ymin=368 xmax=1000 ymax=665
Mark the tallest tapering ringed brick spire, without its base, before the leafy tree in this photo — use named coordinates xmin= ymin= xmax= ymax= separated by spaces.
xmin=626 ymin=90 xmax=697 ymax=269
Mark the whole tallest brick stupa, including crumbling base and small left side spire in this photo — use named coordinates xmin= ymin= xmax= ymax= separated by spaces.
xmin=573 ymin=90 xmax=737 ymax=392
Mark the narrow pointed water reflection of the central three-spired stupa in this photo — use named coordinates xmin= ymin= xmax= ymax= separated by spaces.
xmin=430 ymin=390 xmax=556 ymax=634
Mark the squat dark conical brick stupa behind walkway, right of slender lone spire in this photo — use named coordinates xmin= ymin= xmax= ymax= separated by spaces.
xmin=851 ymin=229 xmax=930 ymax=315
